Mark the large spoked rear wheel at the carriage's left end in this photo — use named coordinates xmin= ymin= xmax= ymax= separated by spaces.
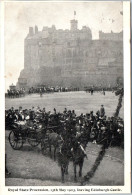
xmin=9 ymin=131 xmax=23 ymax=150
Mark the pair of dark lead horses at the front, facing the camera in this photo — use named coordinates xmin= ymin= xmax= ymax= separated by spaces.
xmin=58 ymin=142 xmax=86 ymax=183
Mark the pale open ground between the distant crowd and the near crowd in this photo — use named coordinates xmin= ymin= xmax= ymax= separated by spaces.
xmin=5 ymin=91 xmax=124 ymax=118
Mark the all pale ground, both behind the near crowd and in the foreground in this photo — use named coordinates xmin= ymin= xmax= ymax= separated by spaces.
xmin=5 ymin=91 xmax=124 ymax=186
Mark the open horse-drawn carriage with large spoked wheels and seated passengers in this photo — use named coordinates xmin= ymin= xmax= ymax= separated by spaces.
xmin=8 ymin=121 xmax=63 ymax=152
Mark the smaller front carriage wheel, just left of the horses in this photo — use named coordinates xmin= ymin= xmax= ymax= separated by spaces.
xmin=28 ymin=132 xmax=40 ymax=147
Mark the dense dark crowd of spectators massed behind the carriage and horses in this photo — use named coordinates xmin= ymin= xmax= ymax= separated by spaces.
xmin=5 ymin=105 xmax=124 ymax=147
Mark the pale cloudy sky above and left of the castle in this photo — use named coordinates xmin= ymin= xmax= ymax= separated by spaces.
xmin=4 ymin=1 xmax=123 ymax=90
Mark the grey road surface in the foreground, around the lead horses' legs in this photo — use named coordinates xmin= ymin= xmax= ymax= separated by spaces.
xmin=5 ymin=131 xmax=124 ymax=186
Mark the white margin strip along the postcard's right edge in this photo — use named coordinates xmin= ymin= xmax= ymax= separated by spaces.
xmin=123 ymin=2 xmax=131 ymax=192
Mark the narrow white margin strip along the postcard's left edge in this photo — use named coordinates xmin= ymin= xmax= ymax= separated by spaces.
xmin=0 ymin=2 xmax=5 ymax=194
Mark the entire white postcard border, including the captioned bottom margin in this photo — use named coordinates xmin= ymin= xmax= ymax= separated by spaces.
xmin=0 ymin=1 xmax=131 ymax=195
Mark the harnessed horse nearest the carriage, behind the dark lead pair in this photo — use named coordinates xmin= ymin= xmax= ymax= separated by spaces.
xmin=41 ymin=131 xmax=63 ymax=160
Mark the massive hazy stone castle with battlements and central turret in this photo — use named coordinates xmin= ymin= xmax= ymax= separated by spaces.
xmin=17 ymin=19 xmax=123 ymax=88
